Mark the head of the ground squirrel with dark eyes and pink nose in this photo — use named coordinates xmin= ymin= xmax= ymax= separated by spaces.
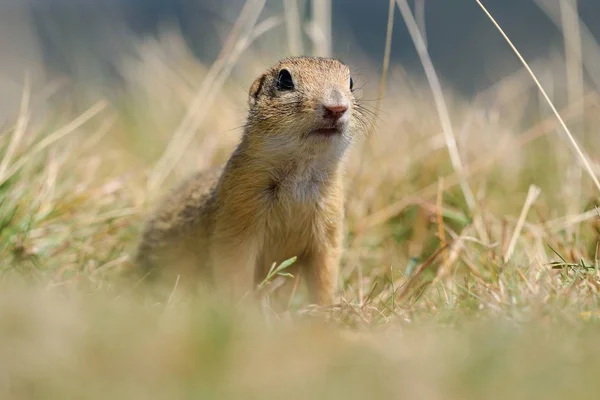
xmin=247 ymin=57 xmax=361 ymax=159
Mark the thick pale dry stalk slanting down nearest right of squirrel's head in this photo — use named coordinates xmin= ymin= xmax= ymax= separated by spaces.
xmin=396 ymin=0 xmax=488 ymax=242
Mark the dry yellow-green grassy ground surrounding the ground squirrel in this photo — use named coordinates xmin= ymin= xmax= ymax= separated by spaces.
xmin=0 ymin=21 xmax=600 ymax=399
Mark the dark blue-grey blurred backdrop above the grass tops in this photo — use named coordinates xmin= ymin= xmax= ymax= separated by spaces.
xmin=0 ymin=0 xmax=600 ymax=94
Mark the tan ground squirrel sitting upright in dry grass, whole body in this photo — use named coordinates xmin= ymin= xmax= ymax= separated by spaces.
xmin=136 ymin=57 xmax=362 ymax=305
